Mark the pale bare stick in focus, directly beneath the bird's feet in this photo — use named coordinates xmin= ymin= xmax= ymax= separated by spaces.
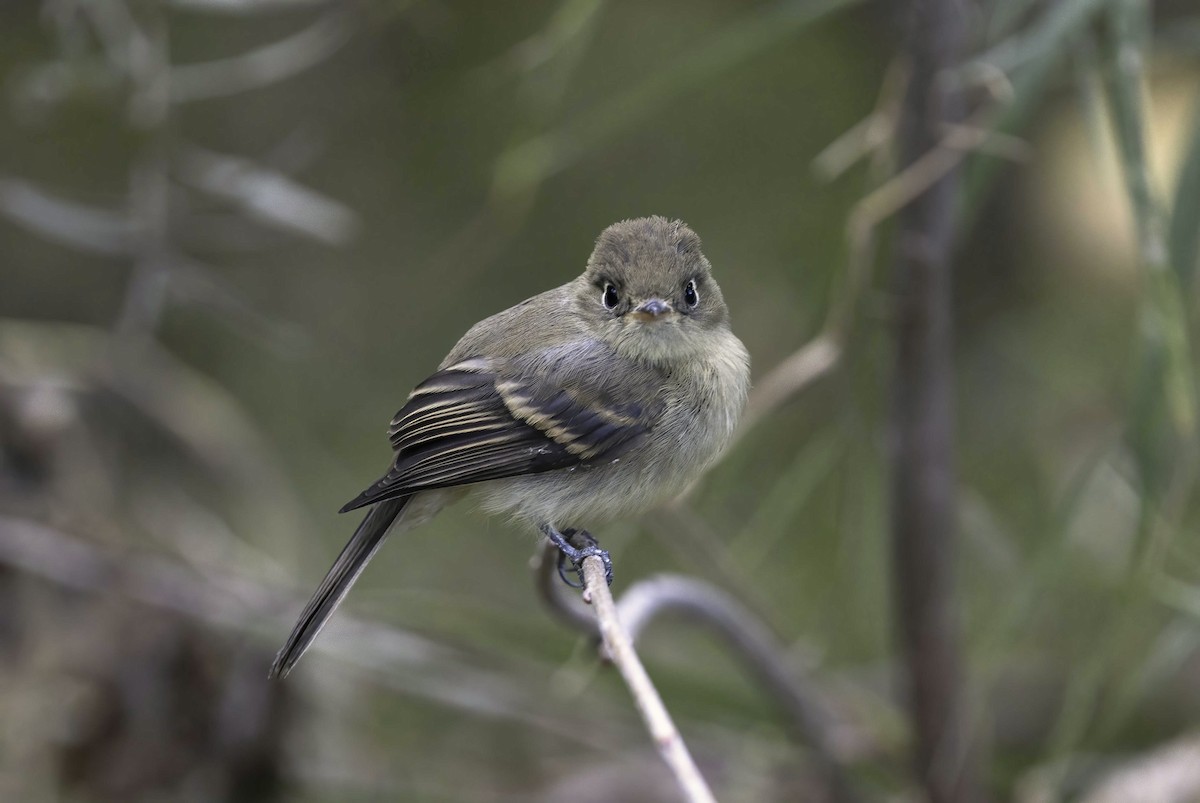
xmin=583 ymin=556 xmax=716 ymax=803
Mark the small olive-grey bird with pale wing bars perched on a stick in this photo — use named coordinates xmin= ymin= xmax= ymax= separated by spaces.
xmin=271 ymin=217 xmax=750 ymax=677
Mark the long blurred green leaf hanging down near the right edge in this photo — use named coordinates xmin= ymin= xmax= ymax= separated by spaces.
xmin=1036 ymin=0 xmax=1196 ymax=757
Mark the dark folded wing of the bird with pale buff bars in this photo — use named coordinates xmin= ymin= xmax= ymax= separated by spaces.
xmin=342 ymin=348 xmax=661 ymax=511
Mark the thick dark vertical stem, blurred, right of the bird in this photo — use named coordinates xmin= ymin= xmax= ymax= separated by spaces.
xmin=890 ymin=0 xmax=979 ymax=803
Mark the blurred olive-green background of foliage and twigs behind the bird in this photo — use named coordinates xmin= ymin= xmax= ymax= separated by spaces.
xmin=0 ymin=0 xmax=1200 ymax=803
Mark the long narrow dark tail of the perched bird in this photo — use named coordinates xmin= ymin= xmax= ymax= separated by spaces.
xmin=269 ymin=497 xmax=412 ymax=678
